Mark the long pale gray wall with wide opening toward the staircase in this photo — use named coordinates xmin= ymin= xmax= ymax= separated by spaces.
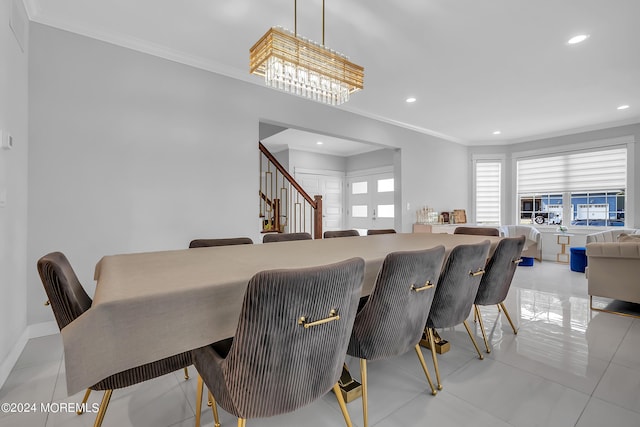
xmin=27 ymin=24 xmax=467 ymax=323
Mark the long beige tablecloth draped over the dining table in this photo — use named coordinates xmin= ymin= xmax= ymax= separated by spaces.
xmin=62 ymin=233 xmax=499 ymax=395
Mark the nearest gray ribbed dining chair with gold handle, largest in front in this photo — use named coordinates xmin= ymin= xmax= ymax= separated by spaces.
xmin=192 ymin=258 xmax=364 ymax=427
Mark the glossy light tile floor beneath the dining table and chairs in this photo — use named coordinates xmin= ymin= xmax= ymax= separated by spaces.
xmin=0 ymin=262 xmax=640 ymax=427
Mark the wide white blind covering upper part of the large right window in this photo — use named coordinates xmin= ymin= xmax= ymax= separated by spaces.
xmin=517 ymin=148 xmax=627 ymax=194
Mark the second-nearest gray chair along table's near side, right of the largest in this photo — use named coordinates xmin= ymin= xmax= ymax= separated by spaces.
xmin=347 ymin=246 xmax=444 ymax=427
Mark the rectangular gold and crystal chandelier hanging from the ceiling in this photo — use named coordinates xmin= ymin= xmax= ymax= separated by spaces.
xmin=249 ymin=27 xmax=364 ymax=105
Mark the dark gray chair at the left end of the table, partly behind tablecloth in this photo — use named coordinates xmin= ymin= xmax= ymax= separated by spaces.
xmin=37 ymin=252 xmax=191 ymax=427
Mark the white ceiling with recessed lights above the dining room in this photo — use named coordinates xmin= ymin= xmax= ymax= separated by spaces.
xmin=24 ymin=0 xmax=640 ymax=145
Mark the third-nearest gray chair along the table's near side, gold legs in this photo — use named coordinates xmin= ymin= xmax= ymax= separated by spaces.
xmin=426 ymin=240 xmax=490 ymax=390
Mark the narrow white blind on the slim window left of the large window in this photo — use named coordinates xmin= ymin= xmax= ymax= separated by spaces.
xmin=475 ymin=161 xmax=502 ymax=224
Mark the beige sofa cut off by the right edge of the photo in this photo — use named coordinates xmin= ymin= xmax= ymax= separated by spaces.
xmin=586 ymin=229 xmax=640 ymax=309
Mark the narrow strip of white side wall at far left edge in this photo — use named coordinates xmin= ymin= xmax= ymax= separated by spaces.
xmin=0 ymin=0 xmax=29 ymax=384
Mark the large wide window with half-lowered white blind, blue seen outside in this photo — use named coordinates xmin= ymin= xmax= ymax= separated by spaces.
xmin=517 ymin=147 xmax=627 ymax=226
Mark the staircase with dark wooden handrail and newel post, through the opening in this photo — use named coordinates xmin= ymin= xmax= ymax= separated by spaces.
xmin=258 ymin=142 xmax=322 ymax=239
